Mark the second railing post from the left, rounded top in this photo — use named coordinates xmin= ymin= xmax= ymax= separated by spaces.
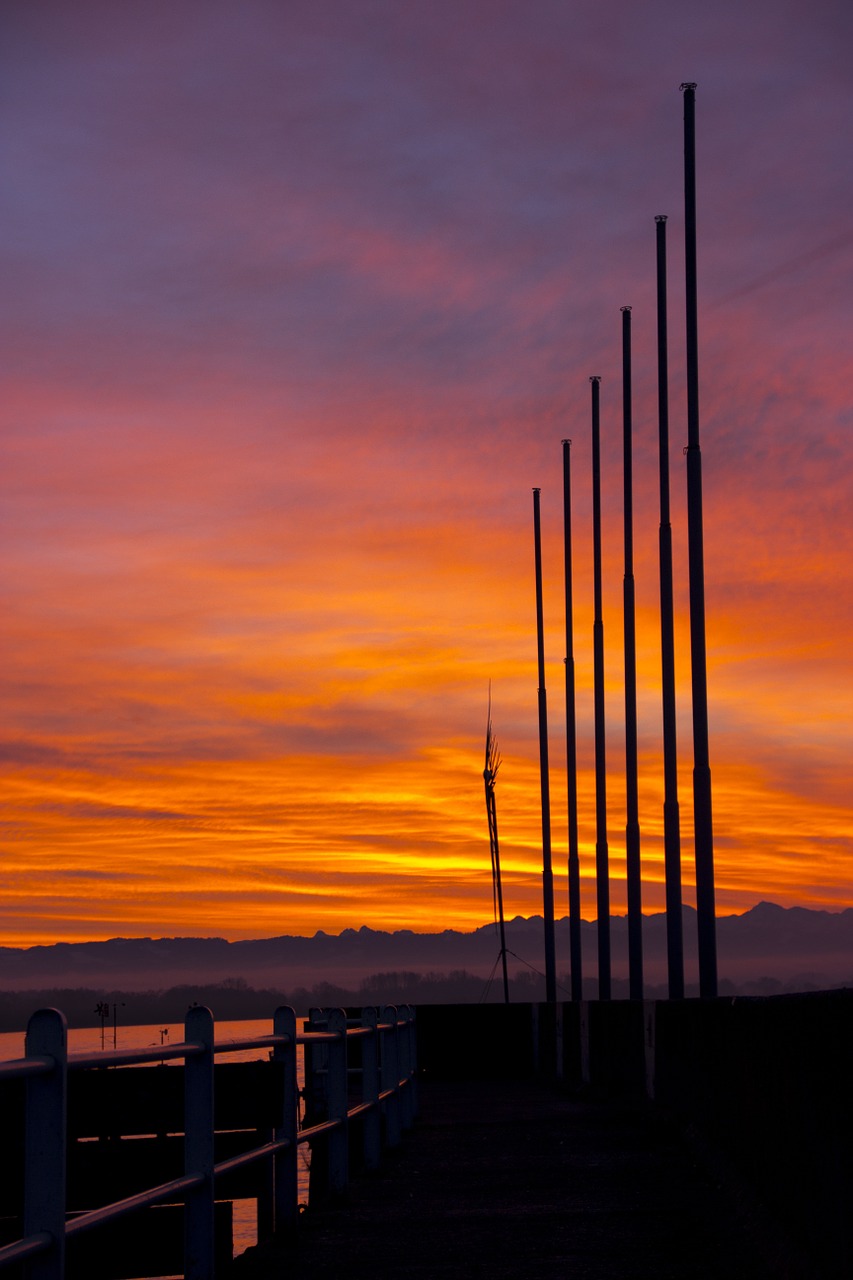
xmin=183 ymin=1005 xmax=214 ymax=1280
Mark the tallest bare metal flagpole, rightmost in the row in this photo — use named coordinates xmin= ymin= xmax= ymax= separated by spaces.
xmin=681 ymin=82 xmax=717 ymax=997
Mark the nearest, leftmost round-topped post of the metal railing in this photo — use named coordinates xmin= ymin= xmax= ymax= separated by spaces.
xmin=23 ymin=1009 xmax=68 ymax=1280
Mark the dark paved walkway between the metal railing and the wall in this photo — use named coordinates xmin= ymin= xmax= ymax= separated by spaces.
xmin=234 ymin=1082 xmax=816 ymax=1280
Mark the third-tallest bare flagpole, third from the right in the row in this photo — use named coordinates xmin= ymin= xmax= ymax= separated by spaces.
xmin=621 ymin=307 xmax=643 ymax=1000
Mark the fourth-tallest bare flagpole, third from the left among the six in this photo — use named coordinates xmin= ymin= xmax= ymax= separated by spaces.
xmin=589 ymin=378 xmax=611 ymax=1000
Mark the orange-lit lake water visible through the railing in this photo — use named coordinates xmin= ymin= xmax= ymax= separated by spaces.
xmin=0 ymin=1018 xmax=309 ymax=1269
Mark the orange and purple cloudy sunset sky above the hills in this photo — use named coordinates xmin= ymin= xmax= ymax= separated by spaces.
xmin=0 ymin=0 xmax=853 ymax=946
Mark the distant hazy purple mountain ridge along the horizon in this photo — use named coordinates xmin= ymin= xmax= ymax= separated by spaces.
xmin=0 ymin=902 xmax=853 ymax=996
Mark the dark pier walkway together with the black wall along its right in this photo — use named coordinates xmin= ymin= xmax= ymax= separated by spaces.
xmin=257 ymin=991 xmax=853 ymax=1280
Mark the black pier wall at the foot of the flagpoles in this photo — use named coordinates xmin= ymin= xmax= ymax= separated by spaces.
xmin=418 ymin=989 xmax=853 ymax=1275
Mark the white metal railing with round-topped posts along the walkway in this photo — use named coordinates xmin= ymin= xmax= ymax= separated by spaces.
xmin=0 ymin=1006 xmax=416 ymax=1280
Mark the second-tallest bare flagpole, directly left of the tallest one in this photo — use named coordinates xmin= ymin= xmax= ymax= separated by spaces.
xmin=654 ymin=214 xmax=684 ymax=1000
